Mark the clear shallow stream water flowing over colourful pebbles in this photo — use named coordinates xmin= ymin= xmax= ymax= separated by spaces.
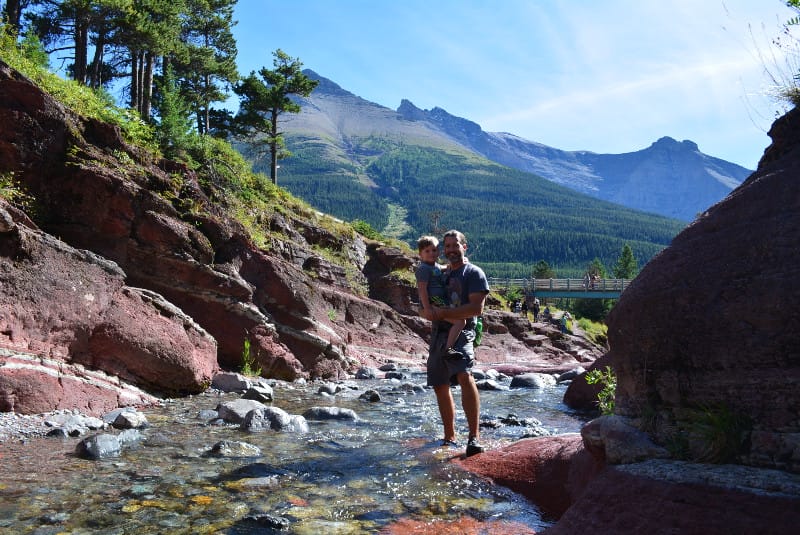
xmin=0 ymin=374 xmax=583 ymax=535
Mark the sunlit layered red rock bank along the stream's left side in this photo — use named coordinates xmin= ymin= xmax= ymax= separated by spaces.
xmin=0 ymin=62 xmax=600 ymax=413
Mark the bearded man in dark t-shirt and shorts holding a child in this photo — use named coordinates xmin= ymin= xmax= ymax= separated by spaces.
xmin=421 ymin=230 xmax=489 ymax=457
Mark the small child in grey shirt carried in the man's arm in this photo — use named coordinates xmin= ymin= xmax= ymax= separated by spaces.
xmin=414 ymin=236 xmax=467 ymax=359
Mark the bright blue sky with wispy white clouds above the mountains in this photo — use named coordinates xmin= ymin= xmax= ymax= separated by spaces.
xmin=234 ymin=0 xmax=800 ymax=169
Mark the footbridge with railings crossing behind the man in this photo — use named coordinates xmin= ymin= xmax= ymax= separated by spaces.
xmin=489 ymin=277 xmax=631 ymax=299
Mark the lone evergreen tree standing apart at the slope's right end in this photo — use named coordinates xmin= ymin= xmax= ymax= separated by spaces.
xmin=234 ymin=49 xmax=319 ymax=184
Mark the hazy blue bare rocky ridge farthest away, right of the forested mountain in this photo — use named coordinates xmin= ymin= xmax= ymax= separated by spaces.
xmin=397 ymin=100 xmax=752 ymax=221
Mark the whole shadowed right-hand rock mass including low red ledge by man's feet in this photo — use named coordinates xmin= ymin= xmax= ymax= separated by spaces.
xmin=456 ymin=110 xmax=800 ymax=534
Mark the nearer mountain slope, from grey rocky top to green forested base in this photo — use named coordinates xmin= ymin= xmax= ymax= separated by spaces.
xmin=255 ymin=71 xmax=684 ymax=276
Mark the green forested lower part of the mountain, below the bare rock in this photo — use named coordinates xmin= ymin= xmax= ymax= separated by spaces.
xmin=270 ymin=137 xmax=683 ymax=277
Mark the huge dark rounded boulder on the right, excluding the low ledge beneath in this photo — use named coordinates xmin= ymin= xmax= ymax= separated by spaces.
xmin=607 ymin=109 xmax=800 ymax=472
